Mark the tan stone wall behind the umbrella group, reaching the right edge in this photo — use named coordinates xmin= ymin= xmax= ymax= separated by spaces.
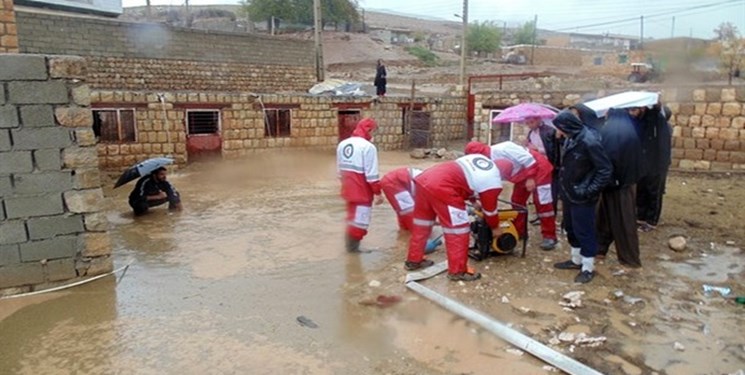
xmin=474 ymin=86 xmax=745 ymax=170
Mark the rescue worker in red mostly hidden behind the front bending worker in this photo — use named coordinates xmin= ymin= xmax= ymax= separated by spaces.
xmin=380 ymin=167 xmax=422 ymax=231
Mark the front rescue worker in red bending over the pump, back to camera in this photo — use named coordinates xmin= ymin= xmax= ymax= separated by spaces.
xmin=404 ymin=155 xmax=502 ymax=281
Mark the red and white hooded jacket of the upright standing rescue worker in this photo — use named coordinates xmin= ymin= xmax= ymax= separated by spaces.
xmin=336 ymin=118 xmax=380 ymax=203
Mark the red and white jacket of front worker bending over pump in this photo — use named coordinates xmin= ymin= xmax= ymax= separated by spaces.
xmin=414 ymin=155 xmax=502 ymax=228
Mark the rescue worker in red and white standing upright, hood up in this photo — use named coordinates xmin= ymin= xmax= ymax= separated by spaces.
xmin=336 ymin=118 xmax=383 ymax=253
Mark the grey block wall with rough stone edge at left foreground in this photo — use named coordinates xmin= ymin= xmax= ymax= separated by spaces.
xmin=0 ymin=54 xmax=112 ymax=294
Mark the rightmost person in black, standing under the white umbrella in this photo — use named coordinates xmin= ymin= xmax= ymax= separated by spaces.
xmin=636 ymin=106 xmax=673 ymax=232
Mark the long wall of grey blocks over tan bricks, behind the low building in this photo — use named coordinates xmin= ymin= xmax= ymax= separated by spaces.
xmin=15 ymin=10 xmax=315 ymax=92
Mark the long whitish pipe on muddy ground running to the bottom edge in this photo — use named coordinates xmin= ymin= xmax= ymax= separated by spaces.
xmin=406 ymin=281 xmax=602 ymax=375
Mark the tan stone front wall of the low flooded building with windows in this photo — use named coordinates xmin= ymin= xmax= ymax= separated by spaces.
xmin=91 ymin=90 xmax=466 ymax=169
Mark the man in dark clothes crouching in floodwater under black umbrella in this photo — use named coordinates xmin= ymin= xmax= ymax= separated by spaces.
xmin=129 ymin=167 xmax=181 ymax=216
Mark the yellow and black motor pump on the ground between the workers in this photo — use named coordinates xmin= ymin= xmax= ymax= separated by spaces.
xmin=468 ymin=209 xmax=528 ymax=260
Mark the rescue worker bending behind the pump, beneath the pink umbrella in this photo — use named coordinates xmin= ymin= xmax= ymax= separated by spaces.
xmin=465 ymin=141 xmax=558 ymax=251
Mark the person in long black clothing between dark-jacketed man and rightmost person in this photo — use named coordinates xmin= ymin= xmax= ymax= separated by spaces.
xmin=597 ymin=107 xmax=647 ymax=268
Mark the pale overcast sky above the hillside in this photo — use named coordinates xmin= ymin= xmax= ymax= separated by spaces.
xmin=123 ymin=0 xmax=745 ymax=38
